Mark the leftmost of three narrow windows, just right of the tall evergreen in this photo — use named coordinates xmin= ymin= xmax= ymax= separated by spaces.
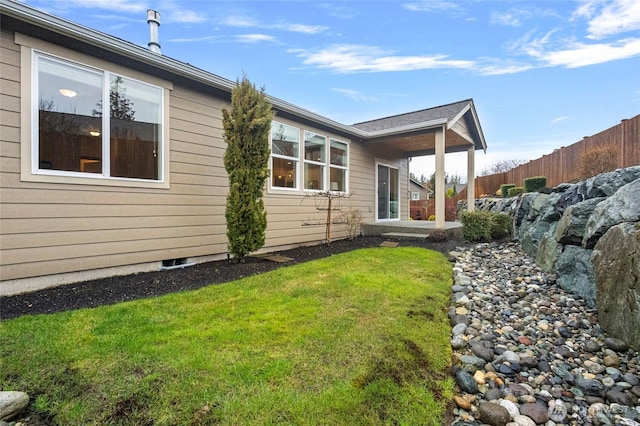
xmin=271 ymin=121 xmax=300 ymax=189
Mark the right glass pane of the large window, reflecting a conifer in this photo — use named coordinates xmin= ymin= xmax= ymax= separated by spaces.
xmin=109 ymin=75 xmax=162 ymax=180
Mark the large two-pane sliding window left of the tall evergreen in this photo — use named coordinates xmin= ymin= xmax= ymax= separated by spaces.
xmin=33 ymin=53 xmax=163 ymax=181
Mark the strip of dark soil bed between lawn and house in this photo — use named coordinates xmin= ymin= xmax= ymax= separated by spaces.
xmin=0 ymin=237 xmax=467 ymax=319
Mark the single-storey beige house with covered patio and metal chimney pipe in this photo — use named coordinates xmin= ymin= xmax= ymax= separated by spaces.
xmin=0 ymin=0 xmax=486 ymax=294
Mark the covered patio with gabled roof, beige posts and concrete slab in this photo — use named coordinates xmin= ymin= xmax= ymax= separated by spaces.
xmin=353 ymin=99 xmax=487 ymax=230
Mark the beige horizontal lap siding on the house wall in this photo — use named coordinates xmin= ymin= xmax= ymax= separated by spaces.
xmin=0 ymin=25 xmax=407 ymax=293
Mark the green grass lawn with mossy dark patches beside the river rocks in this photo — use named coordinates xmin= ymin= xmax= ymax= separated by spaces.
xmin=0 ymin=248 xmax=454 ymax=425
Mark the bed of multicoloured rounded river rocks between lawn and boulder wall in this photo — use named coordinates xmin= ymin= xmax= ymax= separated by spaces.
xmin=449 ymin=242 xmax=640 ymax=426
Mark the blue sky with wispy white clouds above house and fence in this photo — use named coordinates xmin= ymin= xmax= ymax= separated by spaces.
xmin=21 ymin=0 xmax=640 ymax=180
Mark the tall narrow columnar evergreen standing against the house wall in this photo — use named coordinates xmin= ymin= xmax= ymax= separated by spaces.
xmin=222 ymin=77 xmax=274 ymax=261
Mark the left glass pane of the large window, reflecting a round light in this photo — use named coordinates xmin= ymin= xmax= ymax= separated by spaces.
xmin=37 ymin=57 xmax=102 ymax=173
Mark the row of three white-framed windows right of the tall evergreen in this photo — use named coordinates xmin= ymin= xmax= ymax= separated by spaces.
xmin=271 ymin=121 xmax=349 ymax=192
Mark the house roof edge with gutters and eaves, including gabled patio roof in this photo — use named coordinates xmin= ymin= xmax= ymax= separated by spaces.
xmin=0 ymin=0 xmax=486 ymax=156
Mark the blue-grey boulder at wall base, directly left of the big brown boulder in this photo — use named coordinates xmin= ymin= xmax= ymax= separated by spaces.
xmin=556 ymin=246 xmax=596 ymax=308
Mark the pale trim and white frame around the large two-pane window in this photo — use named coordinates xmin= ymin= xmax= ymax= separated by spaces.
xmin=15 ymin=33 xmax=173 ymax=189
